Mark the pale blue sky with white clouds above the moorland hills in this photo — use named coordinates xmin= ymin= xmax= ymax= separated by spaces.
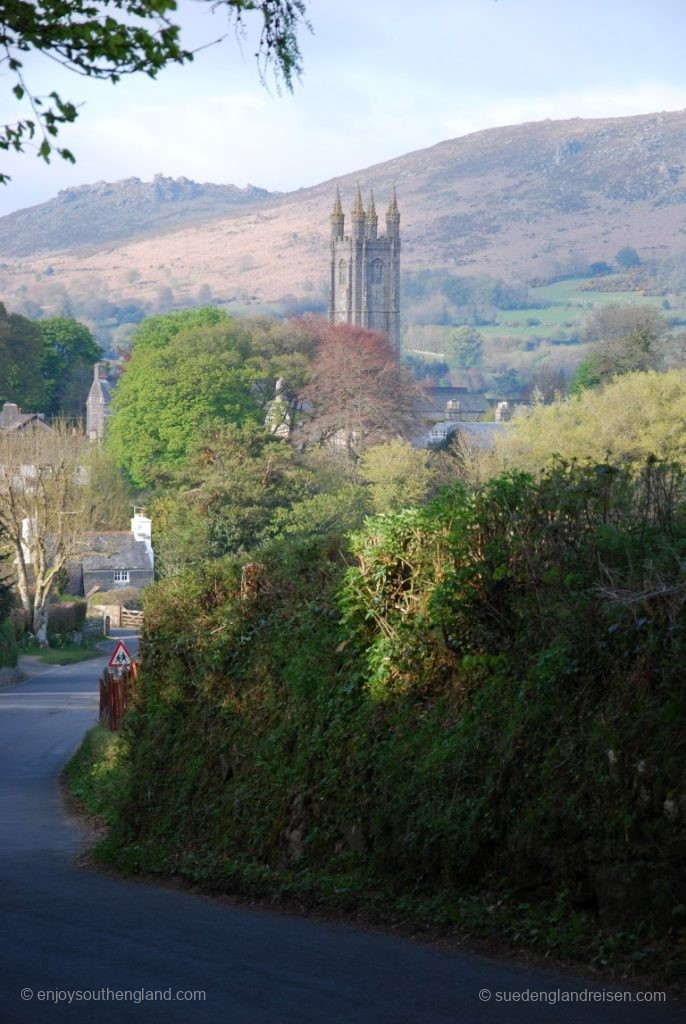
xmin=0 ymin=0 xmax=686 ymax=215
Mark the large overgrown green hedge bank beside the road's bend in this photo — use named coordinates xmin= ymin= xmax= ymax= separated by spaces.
xmin=80 ymin=461 xmax=686 ymax=983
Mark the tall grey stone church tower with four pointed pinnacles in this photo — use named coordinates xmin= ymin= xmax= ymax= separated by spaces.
xmin=329 ymin=185 xmax=400 ymax=352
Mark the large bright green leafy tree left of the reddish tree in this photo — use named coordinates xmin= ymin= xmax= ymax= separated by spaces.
xmin=108 ymin=308 xmax=310 ymax=486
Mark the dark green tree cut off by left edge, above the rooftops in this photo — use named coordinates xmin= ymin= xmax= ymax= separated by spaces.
xmin=0 ymin=302 xmax=47 ymax=412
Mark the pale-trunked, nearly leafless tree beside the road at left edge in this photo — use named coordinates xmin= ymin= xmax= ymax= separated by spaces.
xmin=0 ymin=422 xmax=98 ymax=644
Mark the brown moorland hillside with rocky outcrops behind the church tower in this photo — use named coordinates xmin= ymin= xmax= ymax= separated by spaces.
xmin=0 ymin=111 xmax=686 ymax=337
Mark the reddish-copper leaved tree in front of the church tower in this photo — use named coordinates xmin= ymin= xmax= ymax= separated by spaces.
xmin=301 ymin=316 xmax=421 ymax=460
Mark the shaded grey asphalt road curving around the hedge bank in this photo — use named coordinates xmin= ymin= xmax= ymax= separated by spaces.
xmin=0 ymin=634 xmax=686 ymax=1024
